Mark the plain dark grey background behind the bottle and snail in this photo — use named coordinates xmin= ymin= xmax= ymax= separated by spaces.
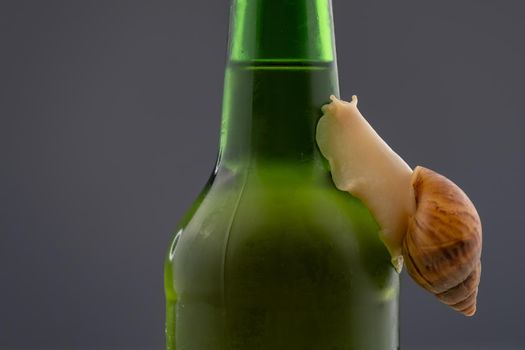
xmin=0 ymin=0 xmax=525 ymax=350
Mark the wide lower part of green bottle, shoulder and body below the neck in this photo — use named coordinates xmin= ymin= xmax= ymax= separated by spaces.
xmin=167 ymin=169 xmax=398 ymax=350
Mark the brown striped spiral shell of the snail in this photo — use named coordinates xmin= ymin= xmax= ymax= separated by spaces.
xmin=403 ymin=167 xmax=482 ymax=316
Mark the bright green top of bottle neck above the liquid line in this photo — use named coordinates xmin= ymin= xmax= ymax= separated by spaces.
xmin=229 ymin=0 xmax=335 ymax=62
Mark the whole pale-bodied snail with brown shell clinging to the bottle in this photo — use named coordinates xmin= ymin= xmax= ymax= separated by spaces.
xmin=316 ymin=96 xmax=482 ymax=316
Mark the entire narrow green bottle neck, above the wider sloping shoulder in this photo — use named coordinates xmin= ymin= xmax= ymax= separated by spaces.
xmin=220 ymin=0 xmax=339 ymax=172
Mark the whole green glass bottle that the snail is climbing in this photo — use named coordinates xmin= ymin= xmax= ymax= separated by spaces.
xmin=165 ymin=0 xmax=399 ymax=350
